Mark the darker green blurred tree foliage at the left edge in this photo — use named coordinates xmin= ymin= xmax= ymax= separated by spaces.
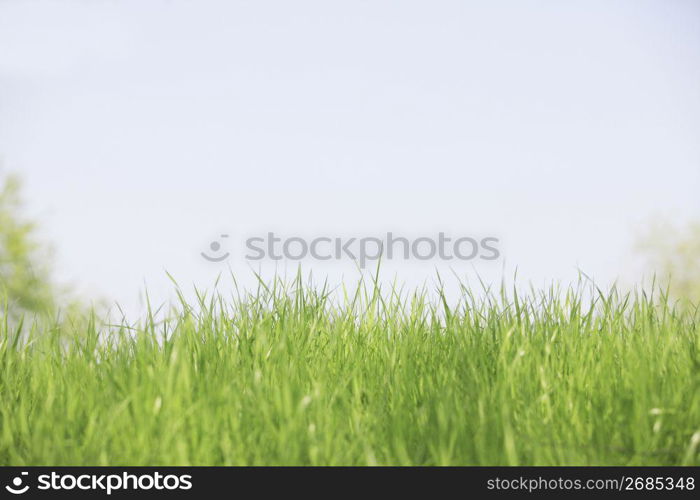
xmin=0 ymin=176 xmax=56 ymax=317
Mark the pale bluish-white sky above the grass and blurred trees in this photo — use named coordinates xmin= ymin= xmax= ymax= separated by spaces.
xmin=0 ymin=0 xmax=700 ymax=316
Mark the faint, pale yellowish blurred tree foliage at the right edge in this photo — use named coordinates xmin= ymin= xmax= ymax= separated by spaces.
xmin=641 ymin=221 xmax=700 ymax=304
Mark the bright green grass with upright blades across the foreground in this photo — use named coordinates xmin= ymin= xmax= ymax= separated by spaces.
xmin=0 ymin=274 xmax=700 ymax=465
